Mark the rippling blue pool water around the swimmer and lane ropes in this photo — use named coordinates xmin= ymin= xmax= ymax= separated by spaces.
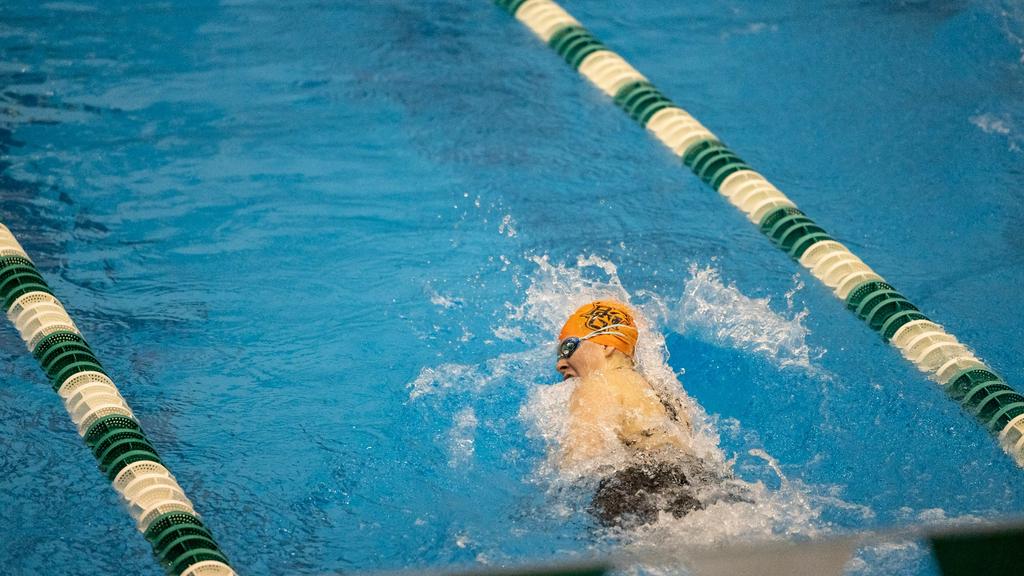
xmin=0 ymin=0 xmax=1024 ymax=575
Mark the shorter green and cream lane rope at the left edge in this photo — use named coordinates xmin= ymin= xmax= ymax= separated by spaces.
xmin=0 ymin=223 xmax=236 ymax=576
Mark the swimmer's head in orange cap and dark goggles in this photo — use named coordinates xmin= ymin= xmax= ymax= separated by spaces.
xmin=555 ymin=300 xmax=639 ymax=378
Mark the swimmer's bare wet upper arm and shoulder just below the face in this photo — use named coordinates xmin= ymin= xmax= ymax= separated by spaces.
xmin=561 ymin=380 xmax=622 ymax=466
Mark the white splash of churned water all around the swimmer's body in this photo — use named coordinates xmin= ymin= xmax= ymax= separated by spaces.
xmin=409 ymin=256 xmax=872 ymax=553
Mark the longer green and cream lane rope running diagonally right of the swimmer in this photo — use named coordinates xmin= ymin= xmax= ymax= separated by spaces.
xmin=493 ymin=0 xmax=1024 ymax=459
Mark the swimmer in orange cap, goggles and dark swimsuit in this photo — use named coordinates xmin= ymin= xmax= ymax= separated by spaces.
xmin=555 ymin=300 xmax=703 ymax=526
